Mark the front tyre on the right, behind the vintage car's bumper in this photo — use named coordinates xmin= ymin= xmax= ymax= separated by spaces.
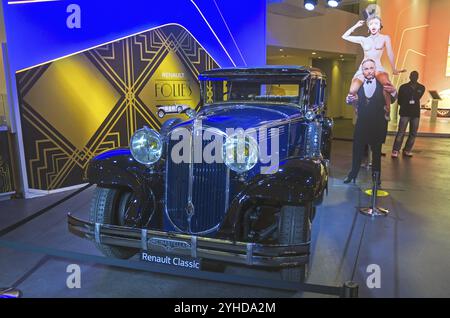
xmin=278 ymin=204 xmax=312 ymax=283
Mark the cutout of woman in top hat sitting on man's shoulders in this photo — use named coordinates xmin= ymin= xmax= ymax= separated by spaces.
xmin=342 ymin=14 xmax=406 ymax=121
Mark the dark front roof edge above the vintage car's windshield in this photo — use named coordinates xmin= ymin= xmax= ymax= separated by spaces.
xmin=199 ymin=65 xmax=326 ymax=80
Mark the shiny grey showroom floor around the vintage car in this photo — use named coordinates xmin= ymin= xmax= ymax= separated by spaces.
xmin=0 ymin=137 xmax=450 ymax=297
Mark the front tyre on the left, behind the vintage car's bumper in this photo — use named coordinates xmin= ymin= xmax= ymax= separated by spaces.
xmin=89 ymin=187 xmax=139 ymax=259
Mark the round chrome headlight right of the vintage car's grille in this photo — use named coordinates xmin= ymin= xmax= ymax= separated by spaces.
xmin=223 ymin=134 xmax=258 ymax=173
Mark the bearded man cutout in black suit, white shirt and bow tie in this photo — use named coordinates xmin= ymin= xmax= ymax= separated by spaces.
xmin=344 ymin=59 xmax=397 ymax=183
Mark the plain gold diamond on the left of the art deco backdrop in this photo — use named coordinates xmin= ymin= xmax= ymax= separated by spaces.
xmin=23 ymin=54 xmax=120 ymax=149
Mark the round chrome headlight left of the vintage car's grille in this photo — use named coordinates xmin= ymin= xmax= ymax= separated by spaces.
xmin=130 ymin=127 xmax=163 ymax=165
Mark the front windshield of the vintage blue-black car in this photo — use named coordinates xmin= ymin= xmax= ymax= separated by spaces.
xmin=202 ymin=79 xmax=304 ymax=105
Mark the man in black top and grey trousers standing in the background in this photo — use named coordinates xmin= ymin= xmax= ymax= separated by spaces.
xmin=391 ymin=71 xmax=425 ymax=158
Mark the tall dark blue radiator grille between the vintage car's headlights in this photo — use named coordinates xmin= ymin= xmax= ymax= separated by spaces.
xmin=165 ymin=126 xmax=229 ymax=234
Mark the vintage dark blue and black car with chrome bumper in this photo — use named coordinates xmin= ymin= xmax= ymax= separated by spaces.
xmin=68 ymin=66 xmax=333 ymax=281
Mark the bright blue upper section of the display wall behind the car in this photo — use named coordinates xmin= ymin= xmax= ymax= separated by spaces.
xmin=2 ymin=0 xmax=266 ymax=72
